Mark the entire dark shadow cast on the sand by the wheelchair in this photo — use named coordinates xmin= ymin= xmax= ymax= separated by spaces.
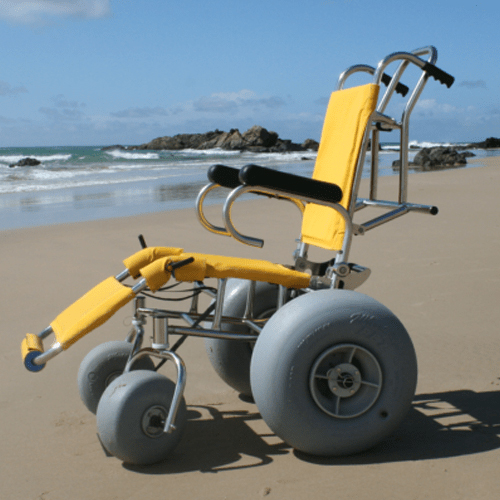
xmin=123 ymin=390 xmax=500 ymax=474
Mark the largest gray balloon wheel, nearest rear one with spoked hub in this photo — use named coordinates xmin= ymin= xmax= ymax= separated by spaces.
xmin=250 ymin=290 xmax=417 ymax=456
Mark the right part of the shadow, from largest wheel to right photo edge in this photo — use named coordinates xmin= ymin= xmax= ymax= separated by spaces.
xmin=294 ymin=390 xmax=500 ymax=465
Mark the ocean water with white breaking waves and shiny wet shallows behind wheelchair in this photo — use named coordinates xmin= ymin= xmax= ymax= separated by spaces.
xmin=0 ymin=143 xmax=500 ymax=230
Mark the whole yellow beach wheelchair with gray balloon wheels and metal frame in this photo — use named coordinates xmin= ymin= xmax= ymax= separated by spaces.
xmin=22 ymin=47 xmax=454 ymax=464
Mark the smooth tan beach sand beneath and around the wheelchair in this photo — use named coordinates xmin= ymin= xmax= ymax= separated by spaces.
xmin=0 ymin=158 xmax=500 ymax=500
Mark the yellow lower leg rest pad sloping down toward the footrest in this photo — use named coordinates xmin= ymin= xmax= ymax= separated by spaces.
xmin=50 ymin=277 xmax=135 ymax=349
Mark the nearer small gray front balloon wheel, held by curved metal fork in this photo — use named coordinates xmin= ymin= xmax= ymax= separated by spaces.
xmin=97 ymin=370 xmax=187 ymax=465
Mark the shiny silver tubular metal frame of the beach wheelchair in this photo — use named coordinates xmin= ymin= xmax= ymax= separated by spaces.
xmin=26 ymin=46 xmax=450 ymax=442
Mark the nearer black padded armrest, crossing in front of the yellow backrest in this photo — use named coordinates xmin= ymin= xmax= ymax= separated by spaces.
xmin=239 ymin=165 xmax=342 ymax=203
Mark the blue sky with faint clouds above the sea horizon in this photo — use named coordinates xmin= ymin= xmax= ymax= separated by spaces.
xmin=0 ymin=0 xmax=500 ymax=147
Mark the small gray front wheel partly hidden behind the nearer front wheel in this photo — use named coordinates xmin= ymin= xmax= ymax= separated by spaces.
xmin=78 ymin=340 xmax=154 ymax=413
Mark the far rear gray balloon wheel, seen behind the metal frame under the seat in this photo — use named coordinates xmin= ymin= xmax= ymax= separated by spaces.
xmin=205 ymin=279 xmax=278 ymax=396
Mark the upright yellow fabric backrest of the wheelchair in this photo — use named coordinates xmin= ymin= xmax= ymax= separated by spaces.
xmin=302 ymin=84 xmax=379 ymax=254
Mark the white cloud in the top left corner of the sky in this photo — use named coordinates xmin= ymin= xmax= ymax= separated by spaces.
xmin=0 ymin=0 xmax=111 ymax=24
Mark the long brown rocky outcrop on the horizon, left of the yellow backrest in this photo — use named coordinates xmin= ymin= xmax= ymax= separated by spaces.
xmin=127 ymin=125 xmax=318 ymax=153
